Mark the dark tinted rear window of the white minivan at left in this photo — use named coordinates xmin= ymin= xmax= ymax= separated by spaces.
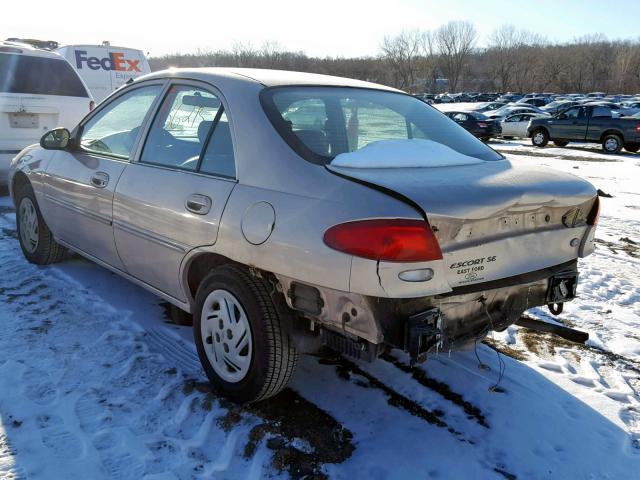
xmin=0 ymin=53 xmax=89 ymax=97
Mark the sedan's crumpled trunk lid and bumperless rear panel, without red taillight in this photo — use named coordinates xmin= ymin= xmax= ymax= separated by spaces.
xmin=328 ymin=159 xmax=599 ymax=359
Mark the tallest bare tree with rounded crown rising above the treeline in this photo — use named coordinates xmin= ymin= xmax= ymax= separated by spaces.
xmin=434 ymin=21 xmax=478 ymax=92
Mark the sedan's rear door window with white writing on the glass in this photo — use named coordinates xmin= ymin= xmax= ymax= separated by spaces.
xmin=140 ymin=85 xmax=222 ymax=171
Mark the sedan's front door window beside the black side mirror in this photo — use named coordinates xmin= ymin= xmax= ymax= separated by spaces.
xmin=80 ymin=85 xmax=162 ymax=159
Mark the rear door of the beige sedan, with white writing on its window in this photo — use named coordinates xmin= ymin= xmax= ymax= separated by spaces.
xmin=113 ymin=82 xmax=236 ymax=301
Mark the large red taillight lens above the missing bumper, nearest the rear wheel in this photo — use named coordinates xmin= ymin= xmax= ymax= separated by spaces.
xmin=324 ymin=219 xmax=442 ymax=262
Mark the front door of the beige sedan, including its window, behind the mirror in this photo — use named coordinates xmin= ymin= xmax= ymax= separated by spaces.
xmin=44 ymin=82 xmax=162 ymax=269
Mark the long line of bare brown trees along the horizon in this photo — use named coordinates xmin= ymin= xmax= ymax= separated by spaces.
xmin=149 ymin=21 xmax=640 ymax=94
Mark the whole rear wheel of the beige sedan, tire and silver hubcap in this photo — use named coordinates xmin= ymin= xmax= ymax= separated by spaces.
xmin=193 ymin=265 xmax=297 ymax=403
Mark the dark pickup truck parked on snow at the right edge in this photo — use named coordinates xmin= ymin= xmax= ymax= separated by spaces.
xmin=527 ymin=105 xmax=640 ymax=153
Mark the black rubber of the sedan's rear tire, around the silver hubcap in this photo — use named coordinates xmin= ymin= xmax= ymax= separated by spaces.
xmin=193 ymin=264 xmax=298 ymax=403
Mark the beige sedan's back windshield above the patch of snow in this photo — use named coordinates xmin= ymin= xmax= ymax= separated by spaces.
xmin=261 ymin=86 xmax=503 ymax=164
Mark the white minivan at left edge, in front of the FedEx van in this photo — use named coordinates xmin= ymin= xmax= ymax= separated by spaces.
xmin=0 ymin=41 xmax=94 ymax=185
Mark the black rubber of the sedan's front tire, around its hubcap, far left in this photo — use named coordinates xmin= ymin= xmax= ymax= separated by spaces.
xmin=15 ymin=184 xmax=67 ymax=265
